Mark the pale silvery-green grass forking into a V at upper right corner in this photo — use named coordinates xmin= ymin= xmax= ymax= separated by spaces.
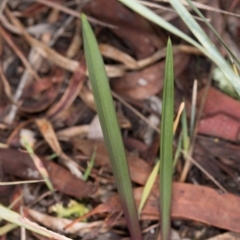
xmin=119 ymin=0 xmax=240 ymax=95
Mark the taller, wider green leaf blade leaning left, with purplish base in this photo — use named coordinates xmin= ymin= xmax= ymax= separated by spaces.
xmin=81 ymin=15 xmax=142 ymax=240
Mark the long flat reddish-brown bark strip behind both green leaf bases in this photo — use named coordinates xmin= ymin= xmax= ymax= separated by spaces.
xmin=92 ymin=183 xmax=240 ymax=232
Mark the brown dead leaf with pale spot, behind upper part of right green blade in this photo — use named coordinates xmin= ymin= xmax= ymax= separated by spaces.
xmin=111 ymin=54 xmax=189 ymax=100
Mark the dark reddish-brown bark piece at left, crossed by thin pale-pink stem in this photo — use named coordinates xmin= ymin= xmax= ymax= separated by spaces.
xmin=0 ymin=149 xmax=94 ymax=198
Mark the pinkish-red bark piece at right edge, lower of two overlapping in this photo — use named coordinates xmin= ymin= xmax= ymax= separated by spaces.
xmin=198 ymin=114 xmax=240 ymax=141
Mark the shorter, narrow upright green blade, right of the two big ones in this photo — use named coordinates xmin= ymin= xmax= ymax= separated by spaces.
xmin=160 ymin=39 xmax=174 ymax=240
